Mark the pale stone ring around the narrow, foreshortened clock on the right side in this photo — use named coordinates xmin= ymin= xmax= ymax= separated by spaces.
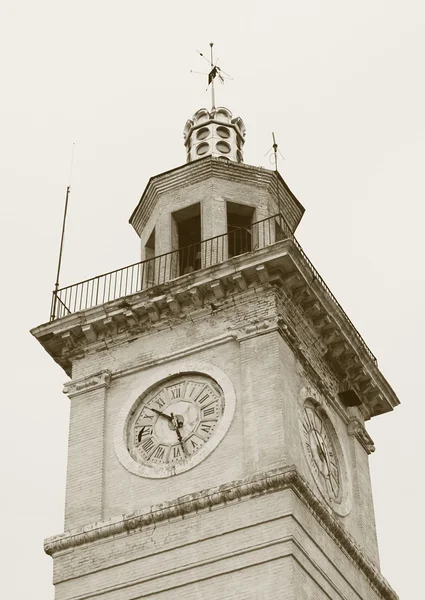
xmin=299 ymin=388 xmax=351 ymax=516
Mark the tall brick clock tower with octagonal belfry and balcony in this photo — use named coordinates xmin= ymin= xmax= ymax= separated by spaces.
xmin=32 ymin=107 xmax=398 ymax=600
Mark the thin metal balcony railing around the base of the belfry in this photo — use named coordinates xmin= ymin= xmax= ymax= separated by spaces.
xmin=50 ymin=213 xmax=377 ymax=363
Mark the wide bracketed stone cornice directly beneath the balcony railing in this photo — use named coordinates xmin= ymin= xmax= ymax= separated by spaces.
xmin=32 ymin=238 xmax=399 ymax=419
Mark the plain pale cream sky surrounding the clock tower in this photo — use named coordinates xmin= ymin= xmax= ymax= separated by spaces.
xmin=0 ymin=0 xmax=425 ymax=600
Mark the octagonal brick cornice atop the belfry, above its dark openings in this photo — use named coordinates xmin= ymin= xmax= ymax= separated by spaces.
xmin=129 ymin=156 xmax=304 ymax=236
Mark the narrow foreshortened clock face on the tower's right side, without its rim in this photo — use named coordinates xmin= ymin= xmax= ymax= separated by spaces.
xmin=301 ymin=401 xmax=341 ymax=504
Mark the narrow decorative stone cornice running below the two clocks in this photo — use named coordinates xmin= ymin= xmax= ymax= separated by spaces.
xmin=44 ymin=466 xmax=398 ymax=600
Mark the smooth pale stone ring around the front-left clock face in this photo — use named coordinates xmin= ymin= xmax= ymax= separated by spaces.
xmin=114 ymin=363 xmax=236 ymax=479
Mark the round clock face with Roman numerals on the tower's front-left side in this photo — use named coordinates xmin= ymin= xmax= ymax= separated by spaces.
xmin=127 ymin=374 xmax=225 ymax=477
